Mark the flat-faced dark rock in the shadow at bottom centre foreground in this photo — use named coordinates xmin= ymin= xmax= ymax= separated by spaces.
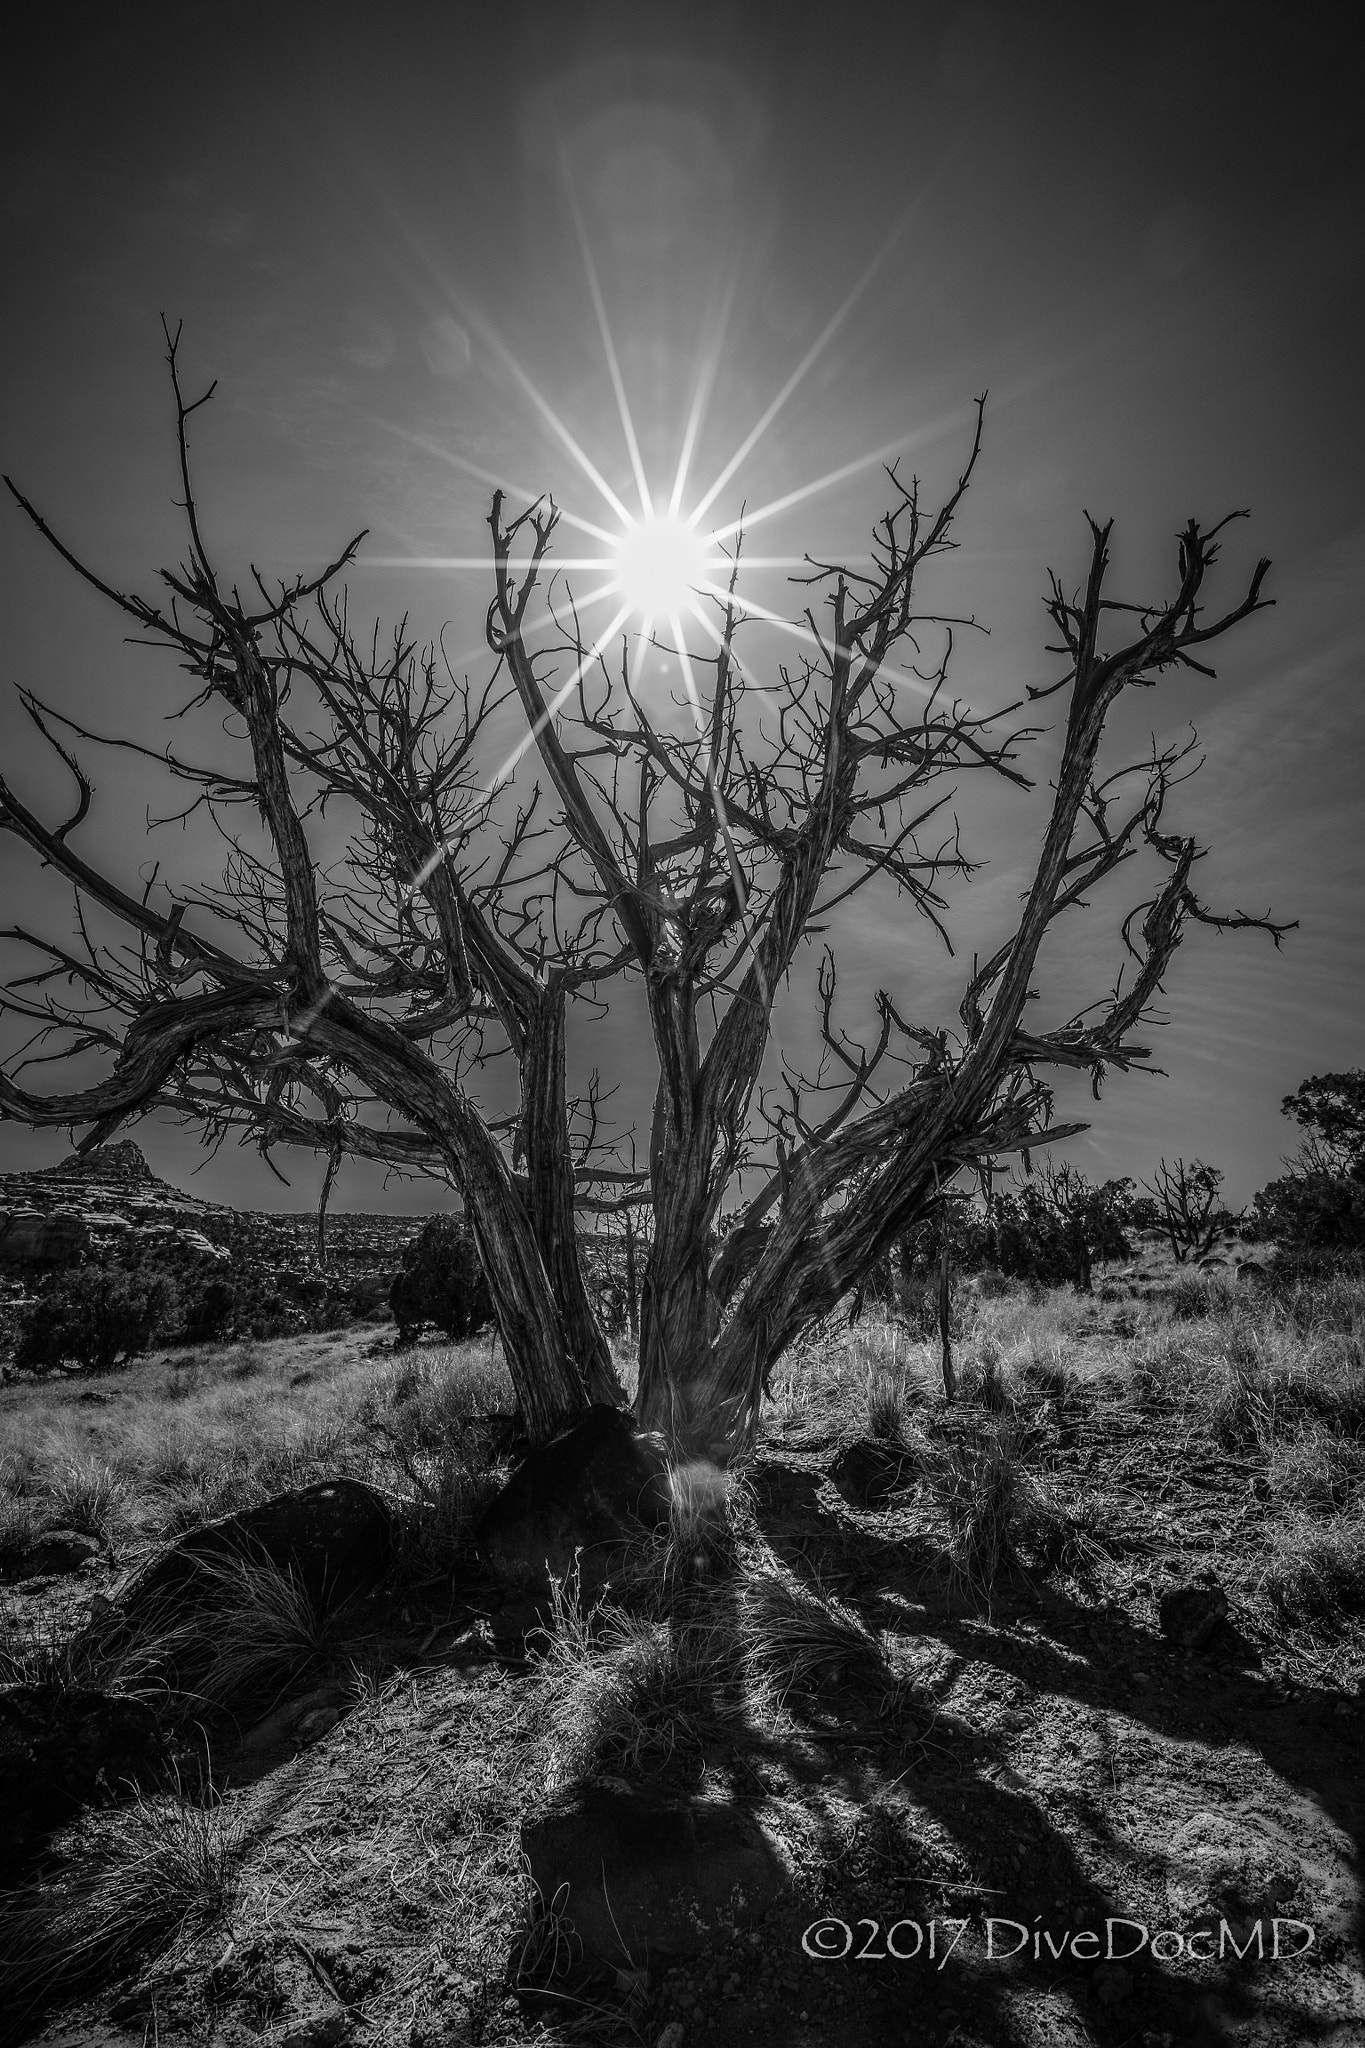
xmin=522 ymin=1780 xmax=792 ymax=1968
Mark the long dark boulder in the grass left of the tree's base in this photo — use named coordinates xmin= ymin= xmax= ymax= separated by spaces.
xmin=119 ymin=1479 xmax=393 ymax=1616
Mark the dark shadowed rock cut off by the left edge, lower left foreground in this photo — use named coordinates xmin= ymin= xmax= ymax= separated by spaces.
xmin=0 ymin=1686 xmax=164 ymax=1872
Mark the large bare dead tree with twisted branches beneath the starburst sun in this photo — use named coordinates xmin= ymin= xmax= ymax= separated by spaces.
xmin=0 ymin=340 xmax=1285 ymax=1462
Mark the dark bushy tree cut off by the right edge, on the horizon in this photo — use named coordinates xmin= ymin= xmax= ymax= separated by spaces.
xmin=1252 ymin=1067 xmax=1365 ymax=1268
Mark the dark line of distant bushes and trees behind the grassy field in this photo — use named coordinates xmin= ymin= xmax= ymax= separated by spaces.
xmin=14 ymin=1067 xmax=1365 ymax=1372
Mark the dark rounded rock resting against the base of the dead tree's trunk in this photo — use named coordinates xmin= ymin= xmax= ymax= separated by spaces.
xmin=479 ymin=1405 xmax=669 ymax=1593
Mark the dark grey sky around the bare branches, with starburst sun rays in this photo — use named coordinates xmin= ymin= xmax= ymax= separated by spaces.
xmin=0 ymin=0 xmax=1365 ymax=1210
